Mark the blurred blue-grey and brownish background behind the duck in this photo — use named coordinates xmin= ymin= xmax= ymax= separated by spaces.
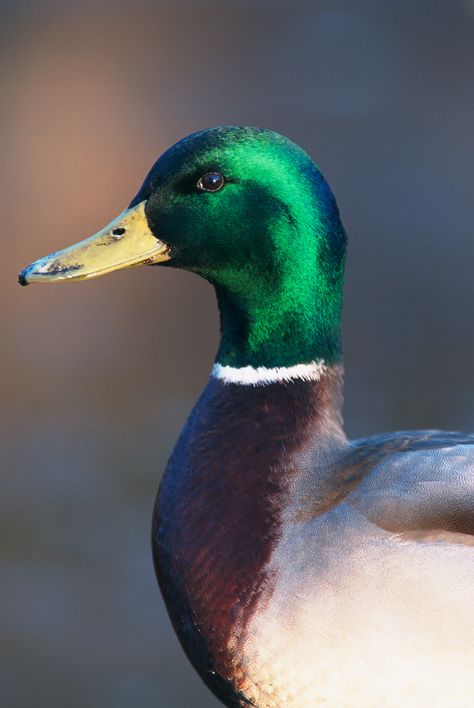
xmin=0 ymin=0 xmax=474 ymax=708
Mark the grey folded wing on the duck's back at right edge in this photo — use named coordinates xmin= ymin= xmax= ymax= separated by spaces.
xmin=345 ymin=430 xmax=474 ymax=546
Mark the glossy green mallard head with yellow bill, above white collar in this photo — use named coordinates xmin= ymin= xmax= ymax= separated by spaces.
xmin=19 ymin=127 xmax=346 ymax=367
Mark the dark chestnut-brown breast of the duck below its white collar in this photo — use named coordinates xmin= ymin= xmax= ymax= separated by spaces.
xmin=153 ymin=375 xmax=340 ymax=706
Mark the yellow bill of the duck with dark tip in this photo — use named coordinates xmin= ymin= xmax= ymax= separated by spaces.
xmin=18 ymin=201 xmax=170 ymax=285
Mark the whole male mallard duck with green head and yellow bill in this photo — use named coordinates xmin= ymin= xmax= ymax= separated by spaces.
xmin=20 ymin=127 xmax=474 ymax=708
